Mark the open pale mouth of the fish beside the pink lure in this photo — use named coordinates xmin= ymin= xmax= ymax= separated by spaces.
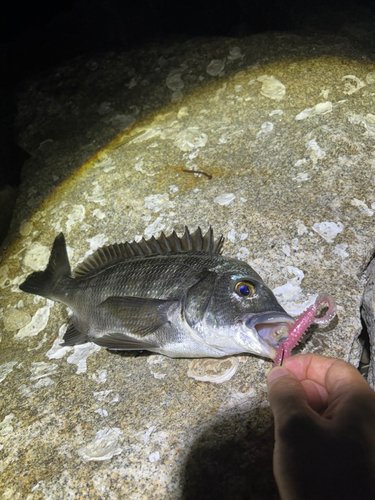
xmin=246 ymin=311 xmax=295 ymax=349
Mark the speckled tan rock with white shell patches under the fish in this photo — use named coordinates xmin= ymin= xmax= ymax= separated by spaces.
xmin=0 ymin=34 xmax=375 ymax=499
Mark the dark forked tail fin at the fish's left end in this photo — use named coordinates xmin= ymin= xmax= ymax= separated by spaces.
xmin=20 ymin=233 xmax=71 ymax=298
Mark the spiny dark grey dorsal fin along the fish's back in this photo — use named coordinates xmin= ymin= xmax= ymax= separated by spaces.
xmin=74 ymin=226 xmax=224 ymax=277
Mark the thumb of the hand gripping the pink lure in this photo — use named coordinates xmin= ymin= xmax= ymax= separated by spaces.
xmin=267 ymin=366 xmax=314 ymax=426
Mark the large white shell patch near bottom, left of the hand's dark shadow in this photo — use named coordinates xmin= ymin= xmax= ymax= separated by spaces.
xmin=78 ymin=427 xmax=123 ymax=460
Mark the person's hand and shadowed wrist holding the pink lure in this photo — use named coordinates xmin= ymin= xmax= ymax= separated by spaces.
xmin=268 ymin=354 xmax=375 ymax=500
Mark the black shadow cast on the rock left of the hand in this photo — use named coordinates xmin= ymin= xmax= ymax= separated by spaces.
xmin=182 ymin=408 xmax=280 ymax=500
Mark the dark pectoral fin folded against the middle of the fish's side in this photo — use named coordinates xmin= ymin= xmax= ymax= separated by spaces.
xmin=99 ymin=297 xmax=179 ymax=337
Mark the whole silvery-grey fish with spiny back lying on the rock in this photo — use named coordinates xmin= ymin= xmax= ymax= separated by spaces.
xmin=20 ymin=226 xmax=294 ymax=359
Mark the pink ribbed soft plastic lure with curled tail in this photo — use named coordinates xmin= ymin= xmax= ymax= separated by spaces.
xmin=273 ymin=294 xmax=336 ymax=366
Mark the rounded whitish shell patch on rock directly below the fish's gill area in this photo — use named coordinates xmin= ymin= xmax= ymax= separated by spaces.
xmin=187 ymin=357 xmax=238 ymax=384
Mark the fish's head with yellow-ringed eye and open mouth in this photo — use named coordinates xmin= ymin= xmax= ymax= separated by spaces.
xmin=187 ymin=259 xmax=294 ymax=359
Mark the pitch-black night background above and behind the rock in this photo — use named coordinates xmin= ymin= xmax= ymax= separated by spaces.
xmin=0 ymin=0 xmax=375 ymax=241
